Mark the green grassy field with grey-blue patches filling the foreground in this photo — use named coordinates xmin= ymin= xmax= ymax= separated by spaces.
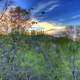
xmin=0 ymin=34 xmax=80 ymax=80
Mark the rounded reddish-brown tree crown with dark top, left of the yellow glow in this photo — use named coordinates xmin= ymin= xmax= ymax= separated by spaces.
xmin=12 ymin=7 xmax=31 ymax=31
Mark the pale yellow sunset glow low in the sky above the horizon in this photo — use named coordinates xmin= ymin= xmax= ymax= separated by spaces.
xmin=33 ymin=22 xmax=66 ymax=35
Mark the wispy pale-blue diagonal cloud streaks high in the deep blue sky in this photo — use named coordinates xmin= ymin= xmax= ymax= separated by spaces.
xmin=32 ymin=1 xmax=58 ymax=14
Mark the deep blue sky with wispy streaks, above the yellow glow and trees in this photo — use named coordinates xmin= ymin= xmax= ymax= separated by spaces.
xmin=0 ymin=0 xmax=80 ymax=25
